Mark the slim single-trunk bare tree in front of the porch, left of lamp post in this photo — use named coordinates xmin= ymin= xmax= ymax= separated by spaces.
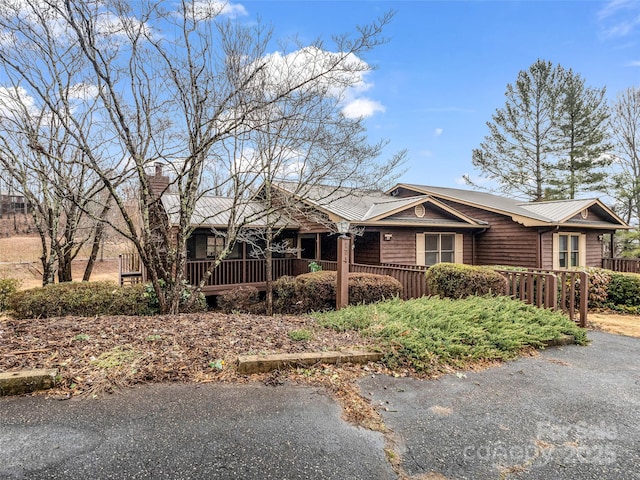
xmin=225 ymin=49 xmax=404 ymax=314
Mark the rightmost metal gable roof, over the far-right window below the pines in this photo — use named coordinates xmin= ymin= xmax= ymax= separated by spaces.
xmin=390 ymin=183 xmax=629 ymax=229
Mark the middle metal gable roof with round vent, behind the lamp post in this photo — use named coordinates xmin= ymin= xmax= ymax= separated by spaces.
xmin=276 ymin=182 xmax=486 ymax=228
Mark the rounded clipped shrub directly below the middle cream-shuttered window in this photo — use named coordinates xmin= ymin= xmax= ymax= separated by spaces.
xmin=426 ymin=263 xmax=508 ymax=298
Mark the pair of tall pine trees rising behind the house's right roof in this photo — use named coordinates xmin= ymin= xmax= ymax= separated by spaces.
xmin=467 ymin=60 xmax=612 ymax=201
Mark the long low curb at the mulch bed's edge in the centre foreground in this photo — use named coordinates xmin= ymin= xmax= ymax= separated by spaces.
xmin=236 ymin=350 xmax=384 ymax=374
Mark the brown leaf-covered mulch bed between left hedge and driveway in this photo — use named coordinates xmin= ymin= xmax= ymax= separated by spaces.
xmin=0 ymin=312 xmax=380 ymax=396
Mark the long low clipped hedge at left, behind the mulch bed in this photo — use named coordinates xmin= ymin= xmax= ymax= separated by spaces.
xmin=9 ymin=282 xmax=152 ymax=318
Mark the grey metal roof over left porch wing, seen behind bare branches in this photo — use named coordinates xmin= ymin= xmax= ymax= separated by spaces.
xmin=162 ymin=193 xmax=298 ymax=228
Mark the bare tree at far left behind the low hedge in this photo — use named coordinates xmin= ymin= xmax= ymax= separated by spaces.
xmin=0 ymin=85 xmax=110 ymax=285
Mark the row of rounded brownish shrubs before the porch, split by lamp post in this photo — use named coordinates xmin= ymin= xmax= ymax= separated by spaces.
xmin=217 ymin=271 xmax=402 ymax=314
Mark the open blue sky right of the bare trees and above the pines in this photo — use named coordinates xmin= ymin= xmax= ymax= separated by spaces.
xmin=238 ymin=1 xmax=640 ymax=187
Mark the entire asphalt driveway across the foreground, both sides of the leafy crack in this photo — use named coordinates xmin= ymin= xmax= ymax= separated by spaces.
xmin=0 ymin=332 xmax=640 ymax=480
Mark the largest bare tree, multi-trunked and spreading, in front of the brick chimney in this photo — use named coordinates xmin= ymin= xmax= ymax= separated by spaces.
xmin=0 ymin=0 xmax=398 ymax=312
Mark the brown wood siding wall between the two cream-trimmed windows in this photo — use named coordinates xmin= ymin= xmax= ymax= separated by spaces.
xmin=441 ymin=199 xmax=538 ymax=268
